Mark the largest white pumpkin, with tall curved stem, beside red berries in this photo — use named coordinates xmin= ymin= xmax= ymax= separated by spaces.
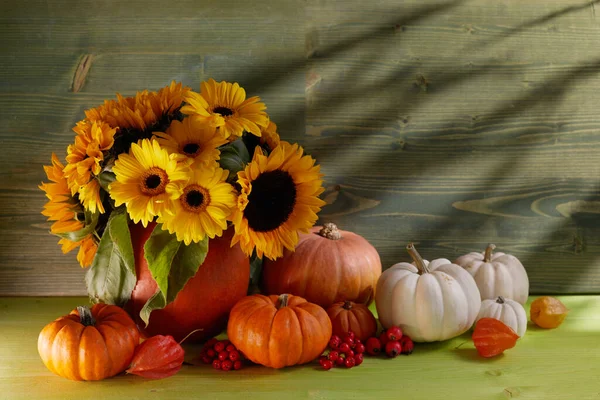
xmin=375 ymin=243 xmax=481 ymax=342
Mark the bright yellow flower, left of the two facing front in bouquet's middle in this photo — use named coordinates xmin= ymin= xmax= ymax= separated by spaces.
xmin=109 ymin=139 xmax=189 ymax=227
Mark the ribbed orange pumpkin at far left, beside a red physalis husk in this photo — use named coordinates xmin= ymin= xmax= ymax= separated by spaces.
xmin=38 ymin=304 xmax=140 ymax=381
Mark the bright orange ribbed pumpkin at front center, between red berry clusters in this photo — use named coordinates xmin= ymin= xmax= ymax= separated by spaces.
xmin=227 ymin=294 xmax=331 ymax=368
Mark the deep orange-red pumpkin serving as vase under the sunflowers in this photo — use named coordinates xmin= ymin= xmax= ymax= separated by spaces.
xmin=129 ymin=224 xmax=250 ymax=341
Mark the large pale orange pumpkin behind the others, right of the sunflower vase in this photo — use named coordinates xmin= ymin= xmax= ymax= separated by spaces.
xmin=262 ymin=223 xmax=381 ymax=308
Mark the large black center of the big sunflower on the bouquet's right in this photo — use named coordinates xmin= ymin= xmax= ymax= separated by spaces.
xmin=244 ymin=170 xmax=296 ymax=232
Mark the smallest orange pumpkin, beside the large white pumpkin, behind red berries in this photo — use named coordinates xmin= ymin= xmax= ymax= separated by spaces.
xmin=327 ymin=301 xmax=377 ymax=342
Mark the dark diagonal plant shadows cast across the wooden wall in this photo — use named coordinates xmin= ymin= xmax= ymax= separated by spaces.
xmin=233 ymin=0 xmax=600 ymax=290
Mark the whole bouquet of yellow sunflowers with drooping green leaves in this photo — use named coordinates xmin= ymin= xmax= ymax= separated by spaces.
xmin=40 ymin=79 xmax=324 ymax=322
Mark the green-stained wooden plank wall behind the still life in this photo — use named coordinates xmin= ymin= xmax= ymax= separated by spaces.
xmin=0 ymin=0 xmax=600 ymax=295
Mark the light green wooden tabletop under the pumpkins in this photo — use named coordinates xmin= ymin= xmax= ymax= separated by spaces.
xmin=0 ymin=296 xmax=600 ymax=400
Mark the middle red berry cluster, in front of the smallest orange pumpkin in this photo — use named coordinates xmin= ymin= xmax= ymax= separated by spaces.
xmin=319 ymin=331 xmax=366 ymax=370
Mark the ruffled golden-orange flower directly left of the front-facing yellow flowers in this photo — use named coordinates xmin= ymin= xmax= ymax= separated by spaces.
xmin=64 ymin=121 xmax=116 ymax=213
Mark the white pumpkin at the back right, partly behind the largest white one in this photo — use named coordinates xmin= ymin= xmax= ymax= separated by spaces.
xmin=454 ymin=244 xmax=529 ymax=304
